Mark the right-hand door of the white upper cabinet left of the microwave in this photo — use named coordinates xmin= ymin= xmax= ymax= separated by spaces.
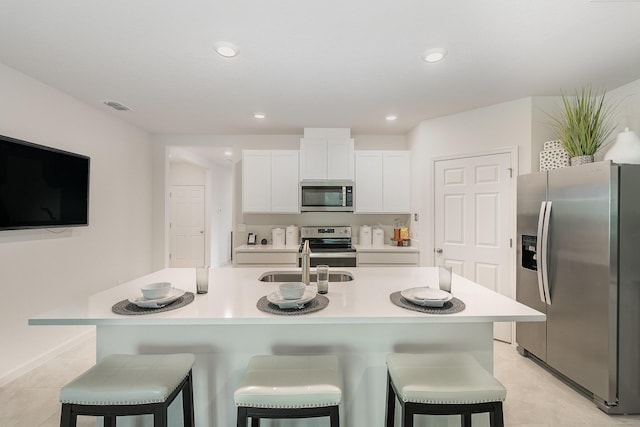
xmin=271 ymin=150 xmax=300 ymax=213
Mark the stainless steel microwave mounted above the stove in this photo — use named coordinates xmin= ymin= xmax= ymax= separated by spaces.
xmin=300 ymin=180 xmax=355 ymax=212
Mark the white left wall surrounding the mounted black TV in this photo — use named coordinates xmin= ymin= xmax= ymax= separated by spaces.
xmin=0 ymin=64 xmax=151 ymax=384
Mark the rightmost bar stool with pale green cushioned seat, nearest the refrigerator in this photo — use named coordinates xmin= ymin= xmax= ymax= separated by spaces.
xmin=385 ymin=353 xmax=507 ymax=427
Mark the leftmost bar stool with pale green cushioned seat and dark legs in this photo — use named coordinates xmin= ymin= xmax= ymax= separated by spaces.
xmin=60 ymin=354 xmax=195 ymax=427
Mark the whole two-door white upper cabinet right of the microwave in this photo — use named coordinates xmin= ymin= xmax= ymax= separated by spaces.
xmin=355 ymin=151 xmax=411 ymax=213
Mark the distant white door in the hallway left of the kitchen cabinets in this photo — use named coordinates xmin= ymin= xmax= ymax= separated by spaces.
xmin=169 ymin=185 xmax=205 ymax=267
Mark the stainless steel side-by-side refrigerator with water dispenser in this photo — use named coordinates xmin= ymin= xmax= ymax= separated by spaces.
xmin=516 ymin=161 xmax=640 ymax=414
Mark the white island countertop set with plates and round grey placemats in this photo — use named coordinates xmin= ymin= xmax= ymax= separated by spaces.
xmin=29 ymin=267 xmax=545 ymax=325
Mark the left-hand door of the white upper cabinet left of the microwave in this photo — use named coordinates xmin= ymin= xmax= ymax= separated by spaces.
xmin=242 ymin=150 xmax=271 ymax=213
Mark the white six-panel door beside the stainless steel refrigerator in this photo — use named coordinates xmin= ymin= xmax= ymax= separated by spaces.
xmin=434 ymin=153 xmax=513 ymax=342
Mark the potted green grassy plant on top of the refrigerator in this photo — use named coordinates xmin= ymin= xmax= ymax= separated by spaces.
xmin=553 ymin=86 xmax=614 ymax=166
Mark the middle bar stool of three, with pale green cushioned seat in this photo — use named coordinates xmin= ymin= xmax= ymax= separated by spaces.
xmin=234 ymin=355 xmax=342 ymax=427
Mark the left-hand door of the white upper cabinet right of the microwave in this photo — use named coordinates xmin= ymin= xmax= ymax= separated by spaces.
xmin=355 ymin=151 xmax=382 ymax=213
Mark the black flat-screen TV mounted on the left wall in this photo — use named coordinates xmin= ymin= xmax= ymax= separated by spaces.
xmin=0 ymin=135 xmax=90 ymax=230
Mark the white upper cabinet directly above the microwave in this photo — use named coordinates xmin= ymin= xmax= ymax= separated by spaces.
xmin=300 ymin=129 xmax=354 ymax=181
